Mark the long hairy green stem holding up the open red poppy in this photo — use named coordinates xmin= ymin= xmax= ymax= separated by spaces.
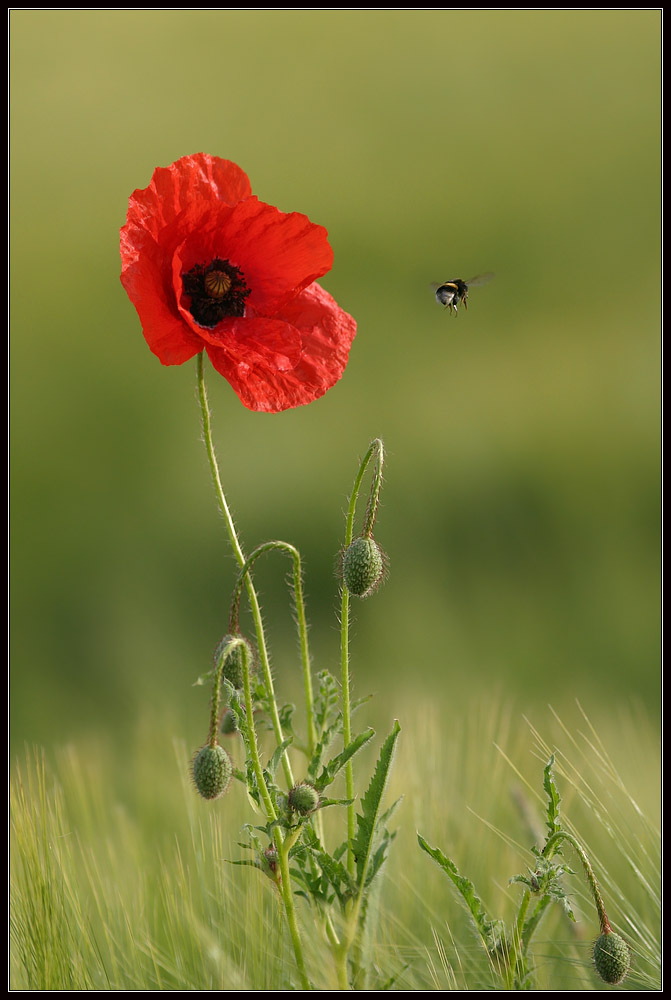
xmin=196 ymin=352 xmax=294 ymax=787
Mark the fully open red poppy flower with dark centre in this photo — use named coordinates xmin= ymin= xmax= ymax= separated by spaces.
xmin=121 ymin=153 xmax=356 ymax=413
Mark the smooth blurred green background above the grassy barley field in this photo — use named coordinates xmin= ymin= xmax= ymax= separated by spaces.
xmin=9 ymin=10 xmax=661 ymax=748
